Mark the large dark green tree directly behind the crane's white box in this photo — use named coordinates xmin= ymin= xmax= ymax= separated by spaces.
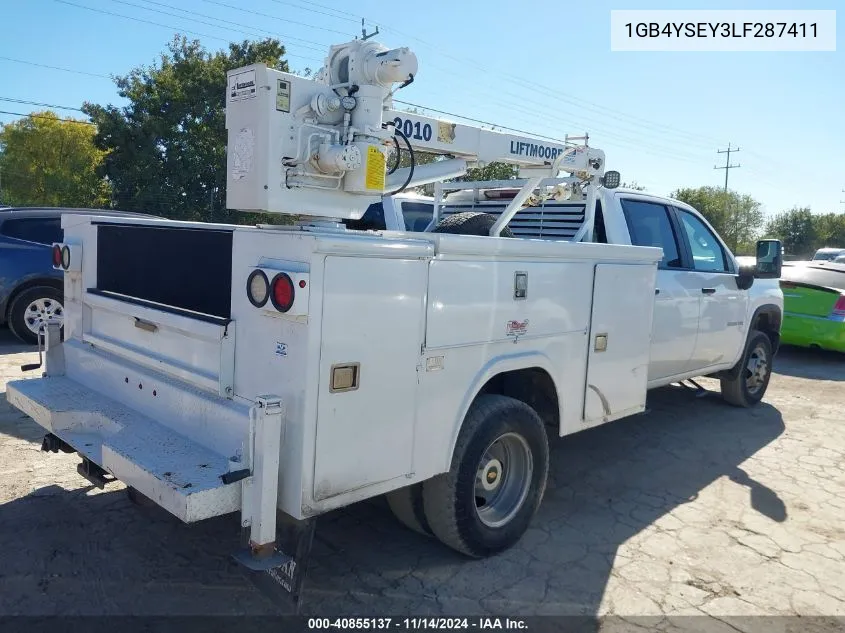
xmin=83 ymin=36 xmax=288 ymax=222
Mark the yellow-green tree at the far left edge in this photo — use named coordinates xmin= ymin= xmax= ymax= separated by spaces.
xmin=0 ymin=111 xmax=109 ymax=208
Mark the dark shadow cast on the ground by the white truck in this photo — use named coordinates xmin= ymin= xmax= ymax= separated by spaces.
xmin=0 ymin=388 xmax=786 ymax=615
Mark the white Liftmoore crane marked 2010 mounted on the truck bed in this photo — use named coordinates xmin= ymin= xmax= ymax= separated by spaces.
xmin=226 ymin=39 xmax=605 ymax=234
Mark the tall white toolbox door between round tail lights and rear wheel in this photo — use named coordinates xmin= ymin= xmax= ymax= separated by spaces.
xmin=313 ymin=256 xmax=428 ymax=501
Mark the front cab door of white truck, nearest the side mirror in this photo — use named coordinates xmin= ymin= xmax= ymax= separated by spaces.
xmin=673 ymin=207 xmax=746 ymax=371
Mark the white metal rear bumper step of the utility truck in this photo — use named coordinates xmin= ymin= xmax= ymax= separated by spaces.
xmin=7 ymin=376 xmax=242 ymax=523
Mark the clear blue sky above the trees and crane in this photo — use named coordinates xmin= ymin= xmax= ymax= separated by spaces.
xmin=0 ymin=0 xmax=845 ymax=216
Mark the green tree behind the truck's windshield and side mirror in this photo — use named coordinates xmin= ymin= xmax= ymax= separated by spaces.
xmin=672 ymin=187 xmax=764 ymax=253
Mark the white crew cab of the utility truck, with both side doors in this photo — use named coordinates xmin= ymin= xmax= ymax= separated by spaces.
xmin=593 ymin=189 xmax=783 ymax=388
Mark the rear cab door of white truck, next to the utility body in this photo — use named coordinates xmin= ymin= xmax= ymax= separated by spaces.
xmin=620 ymin=195 xmax=701 ymax=382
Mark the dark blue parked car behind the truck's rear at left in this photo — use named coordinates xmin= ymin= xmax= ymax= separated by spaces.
xmin=0 ymin=207 xmax=152 ymax=343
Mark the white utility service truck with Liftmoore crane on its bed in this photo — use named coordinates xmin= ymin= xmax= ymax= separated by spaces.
xmin=7 ymin=38 xmax=782 ymax=608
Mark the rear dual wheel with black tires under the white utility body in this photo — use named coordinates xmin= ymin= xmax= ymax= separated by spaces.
xmin=422 ymin=394 xmax=549 ymax=558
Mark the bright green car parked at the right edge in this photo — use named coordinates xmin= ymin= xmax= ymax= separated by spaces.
xmin=780 ymin=261 xmax=845 ymax=353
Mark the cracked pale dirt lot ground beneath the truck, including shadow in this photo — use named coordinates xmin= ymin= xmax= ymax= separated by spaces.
xmin=0 ymin=330 xmax=845 ymax=621
